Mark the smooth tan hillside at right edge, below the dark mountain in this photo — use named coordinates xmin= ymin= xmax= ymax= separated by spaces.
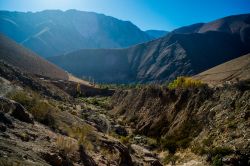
xmin=193 ymin=54 xmax=250 ymax=85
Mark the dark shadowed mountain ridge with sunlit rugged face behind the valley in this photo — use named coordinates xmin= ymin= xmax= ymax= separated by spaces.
xmin=49 ymin=14 xmax=250 ymax=83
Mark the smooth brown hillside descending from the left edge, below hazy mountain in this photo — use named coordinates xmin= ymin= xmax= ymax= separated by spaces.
xmin=0 ymin=34 xmax=68 ymax=80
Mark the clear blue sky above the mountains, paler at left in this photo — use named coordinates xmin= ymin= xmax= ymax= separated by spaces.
xmin=0 ymin=0 xmax=250 ymax=30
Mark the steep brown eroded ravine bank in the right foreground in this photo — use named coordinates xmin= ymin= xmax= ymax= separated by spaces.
xmin=112 ymin=81 xmax=250 ymax=165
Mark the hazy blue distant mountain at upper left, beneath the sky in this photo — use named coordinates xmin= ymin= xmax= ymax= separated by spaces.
xmin=0 ymin=10 xmax=152 ymax=57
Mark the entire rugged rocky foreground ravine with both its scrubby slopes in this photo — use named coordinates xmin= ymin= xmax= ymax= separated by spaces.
xmin=0 ymin=67 xmax=250 ymax=166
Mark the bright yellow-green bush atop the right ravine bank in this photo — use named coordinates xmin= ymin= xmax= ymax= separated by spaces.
xmin=168 ymin=77 xmax=205 ymax=89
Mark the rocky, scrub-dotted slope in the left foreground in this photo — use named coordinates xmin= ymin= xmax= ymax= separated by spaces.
xmin=0 ymin=61 xmax=163 ymax=166
